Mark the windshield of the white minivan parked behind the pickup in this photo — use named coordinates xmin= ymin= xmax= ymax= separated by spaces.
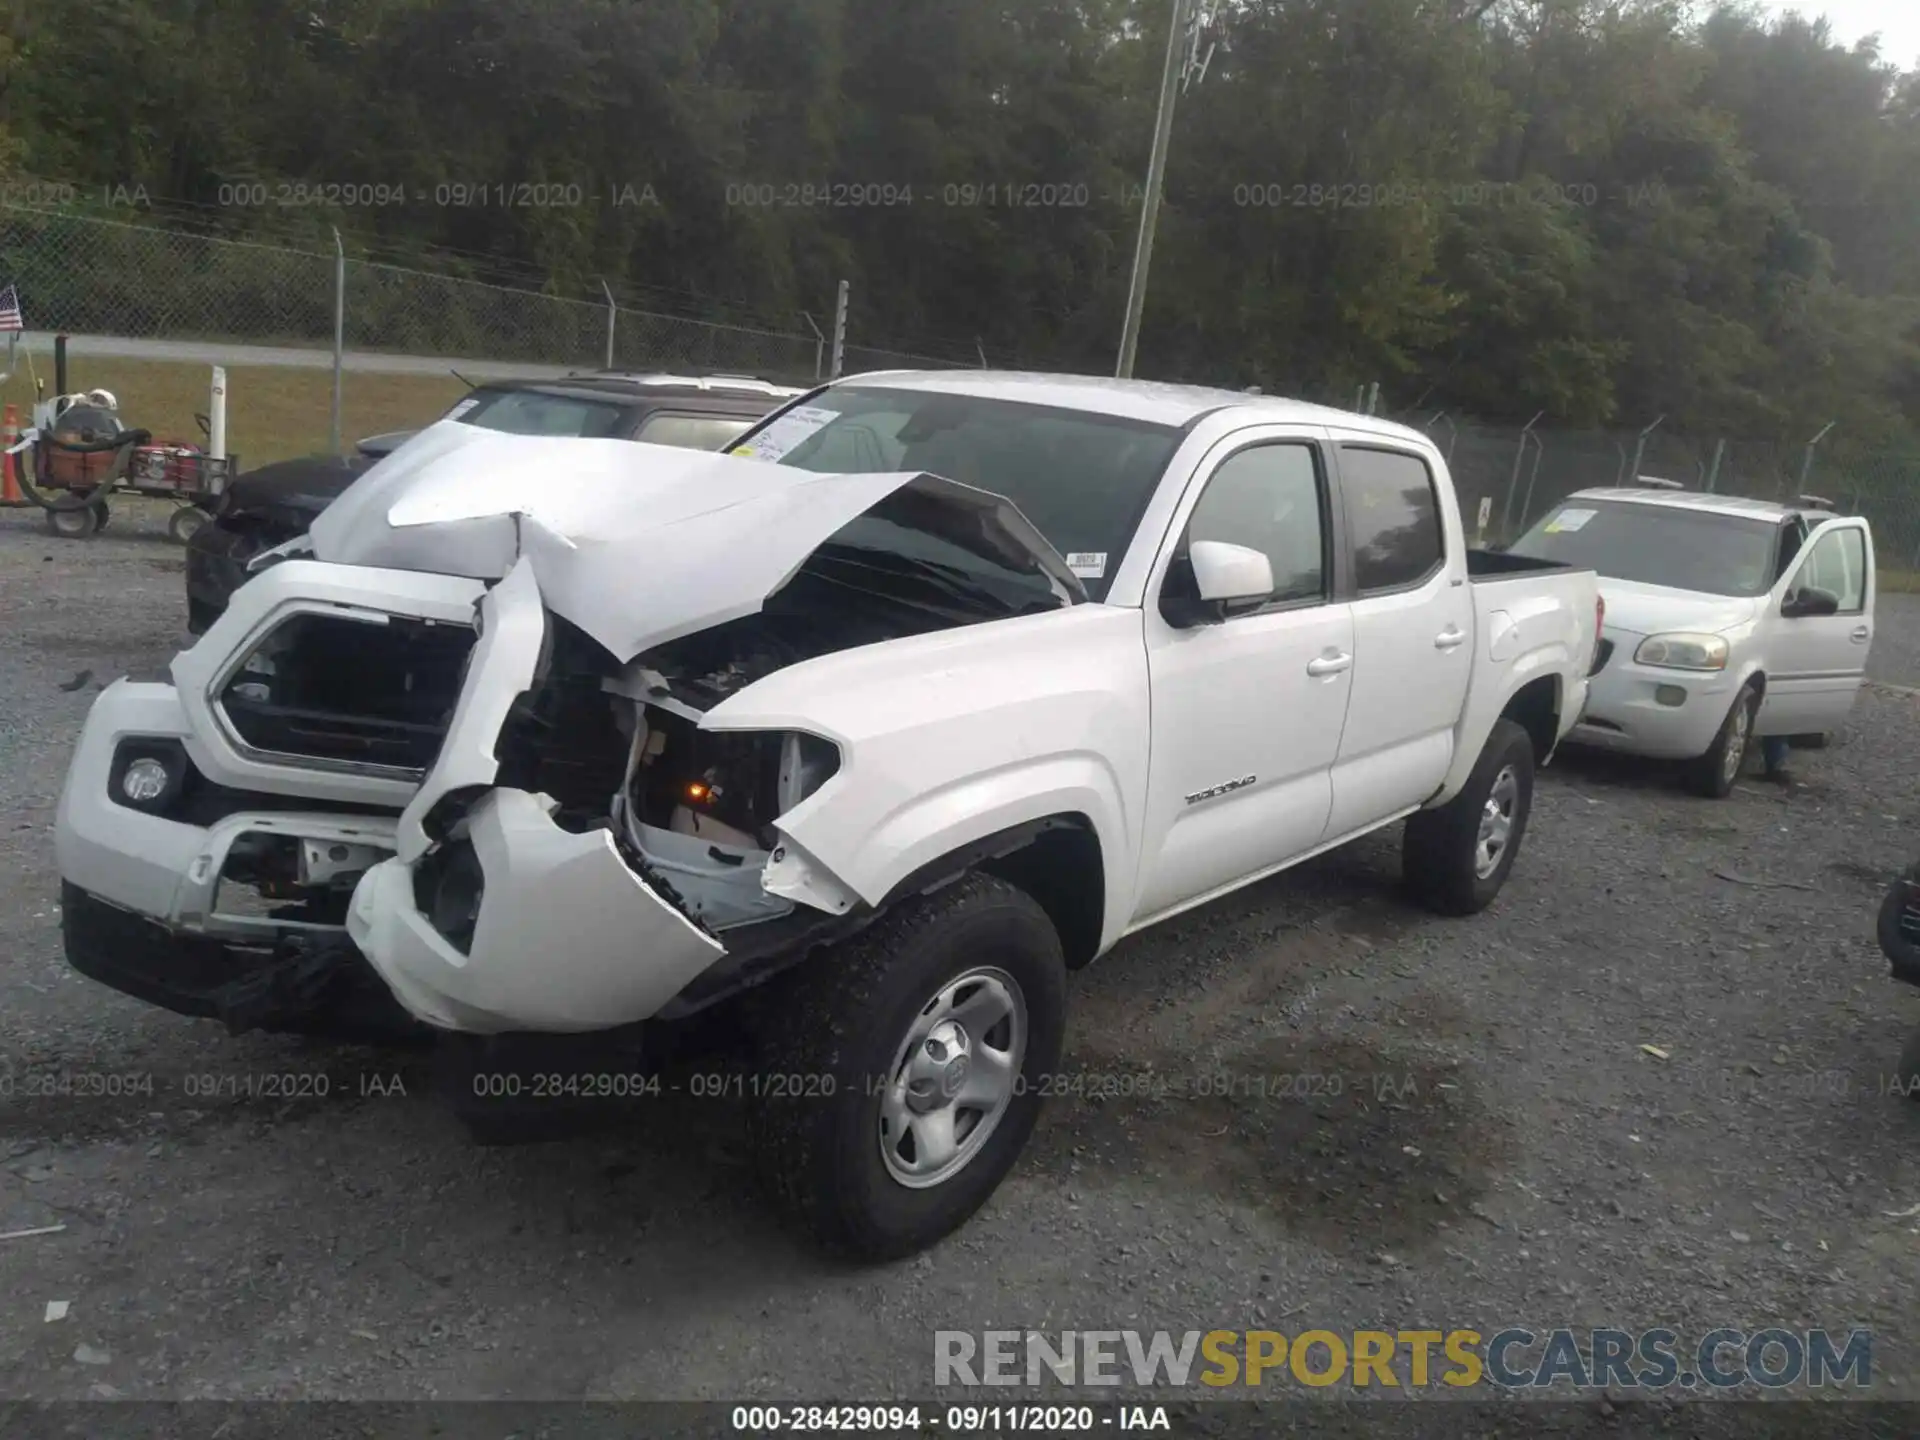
xmin=1509 ymin=497 xmax=1780 ymax=595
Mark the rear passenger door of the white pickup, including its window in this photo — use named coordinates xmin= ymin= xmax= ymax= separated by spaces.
xmin=1327 ymin=438 xmax=1475 ymax=839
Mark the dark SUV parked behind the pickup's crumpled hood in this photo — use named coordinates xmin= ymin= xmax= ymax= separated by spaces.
xmin=186 ymin=371 xmax=801 ymax=636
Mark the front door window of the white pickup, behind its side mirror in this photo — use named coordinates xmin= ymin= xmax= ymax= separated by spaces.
xmin=1187 ymin=444 xmax=1327 ymax=605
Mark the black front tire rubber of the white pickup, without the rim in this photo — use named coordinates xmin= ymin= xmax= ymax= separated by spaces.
xmin=747 ymin=874 xmax=1066 ymax=1261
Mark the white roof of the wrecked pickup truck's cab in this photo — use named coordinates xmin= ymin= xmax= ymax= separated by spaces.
xmin=841 ymin=371 xmax=1428 ymax=444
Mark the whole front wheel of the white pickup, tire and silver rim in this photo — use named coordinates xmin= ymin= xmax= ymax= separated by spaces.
xmin=749 ymin=874 xmax=1066 ymax=1260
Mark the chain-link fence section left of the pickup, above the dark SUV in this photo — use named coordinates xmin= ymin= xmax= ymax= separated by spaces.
xmin=0 ymin=205 xmax=973 ymax=384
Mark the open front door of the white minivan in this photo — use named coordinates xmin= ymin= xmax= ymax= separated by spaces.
xmin=1759 ymin=516 xmax=1874 ymax=735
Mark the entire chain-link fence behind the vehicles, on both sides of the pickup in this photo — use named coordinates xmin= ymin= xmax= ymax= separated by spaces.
xmin=0 ymin=205 xmax=1920 ymax=549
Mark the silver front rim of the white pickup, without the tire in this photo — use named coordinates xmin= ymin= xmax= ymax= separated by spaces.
xmin=879 ymin=966 xmax=1027 ymax=1190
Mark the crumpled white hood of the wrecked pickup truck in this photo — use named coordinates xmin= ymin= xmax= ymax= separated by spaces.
xmin=299 ymin=420 xmax=1087 ymax=660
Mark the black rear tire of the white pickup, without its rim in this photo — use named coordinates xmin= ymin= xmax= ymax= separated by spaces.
xmin=1400 ymin=720 xmax=1534 ymax=916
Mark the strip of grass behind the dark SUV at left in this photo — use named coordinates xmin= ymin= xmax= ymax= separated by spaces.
xmin=0 ymin=357 xmax=467 ymax=470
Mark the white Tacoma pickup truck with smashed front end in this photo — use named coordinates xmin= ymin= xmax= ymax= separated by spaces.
xmin=58 ymin=372 xmax=1603 ymax=1258
